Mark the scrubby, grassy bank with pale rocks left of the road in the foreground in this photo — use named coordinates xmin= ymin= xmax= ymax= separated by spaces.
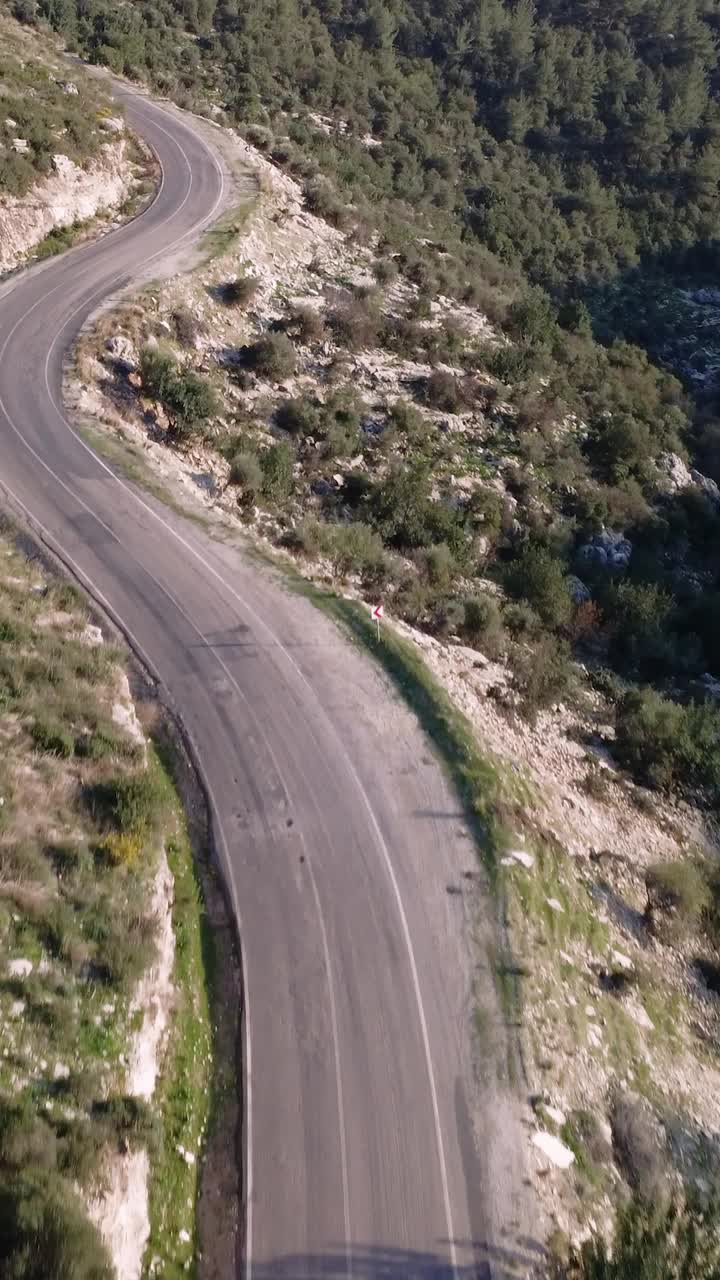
xmin=0 ymin=529 xmax=211 ymax=1280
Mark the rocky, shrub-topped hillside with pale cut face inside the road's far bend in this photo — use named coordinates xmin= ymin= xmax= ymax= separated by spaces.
xmin=0 ymin=8 xmax=149 ymax=274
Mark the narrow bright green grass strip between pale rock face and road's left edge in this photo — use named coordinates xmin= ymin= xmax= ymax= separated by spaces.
xmin=145 ymin=783 xmax=213 ymax=1280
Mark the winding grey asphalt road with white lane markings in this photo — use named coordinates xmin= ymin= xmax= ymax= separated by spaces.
xmin=0 ymin=85 xmax=527 ymax=1280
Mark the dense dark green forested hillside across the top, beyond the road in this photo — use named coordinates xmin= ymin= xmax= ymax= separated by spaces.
xmin=29 ymin=0 xmax=720 ymax=289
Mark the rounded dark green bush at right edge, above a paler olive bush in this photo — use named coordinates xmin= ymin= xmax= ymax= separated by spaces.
xmin=607 ymin=689 xmax=720 ymax=796
